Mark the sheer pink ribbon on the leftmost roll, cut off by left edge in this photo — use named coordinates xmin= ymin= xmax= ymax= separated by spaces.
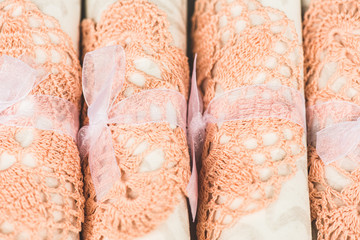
xmin=0 ymin=55 xmax=79 ymax=140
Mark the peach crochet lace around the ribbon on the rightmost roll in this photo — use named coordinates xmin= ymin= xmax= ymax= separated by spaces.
xmin=304 ymin=0 xmax=360 ymax=239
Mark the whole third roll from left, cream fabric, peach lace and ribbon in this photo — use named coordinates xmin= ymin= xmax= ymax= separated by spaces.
xmin=192 ymin=0 xmax=311 ymax=239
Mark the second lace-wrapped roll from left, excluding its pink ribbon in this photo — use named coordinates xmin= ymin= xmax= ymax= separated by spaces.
xmin=82 ymin=0 xmax=190 ymax=240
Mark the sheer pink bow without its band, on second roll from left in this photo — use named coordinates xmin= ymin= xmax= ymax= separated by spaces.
xmin=79 ymin=46 xmax=125 ymax=199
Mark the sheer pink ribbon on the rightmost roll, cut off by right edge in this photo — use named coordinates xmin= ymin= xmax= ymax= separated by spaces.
xmin=308 ymin=101 xmax=360 ymax=165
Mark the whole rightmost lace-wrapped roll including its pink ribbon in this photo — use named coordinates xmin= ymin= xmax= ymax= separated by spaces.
xmin=304 ymin=0 xmax=360 ymax=239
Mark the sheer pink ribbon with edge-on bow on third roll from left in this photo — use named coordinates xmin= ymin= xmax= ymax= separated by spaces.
xmin=188 ymin=71 xmax=306 ymax=220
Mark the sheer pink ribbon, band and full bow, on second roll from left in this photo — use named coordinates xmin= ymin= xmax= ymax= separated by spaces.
xmin=79 ymin=46 xmax=186 ymax=200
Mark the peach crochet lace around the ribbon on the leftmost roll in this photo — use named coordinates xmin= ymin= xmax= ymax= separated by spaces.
xmin=0 ymin=0 xmax=84 ymax=240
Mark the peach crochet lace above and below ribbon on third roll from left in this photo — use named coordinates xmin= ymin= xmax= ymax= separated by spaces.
xmin=193 ymin=0 xmax=306 ymax=239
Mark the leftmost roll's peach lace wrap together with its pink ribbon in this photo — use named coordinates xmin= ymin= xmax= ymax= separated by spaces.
xmin=0 ymin=0 xmax=84 ymax=240
